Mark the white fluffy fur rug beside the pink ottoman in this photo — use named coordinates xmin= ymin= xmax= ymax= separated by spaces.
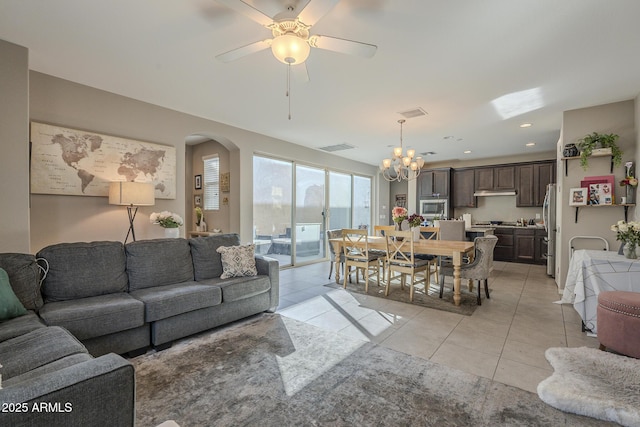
xmin=538 ymin=347 xmax=640 ymax=426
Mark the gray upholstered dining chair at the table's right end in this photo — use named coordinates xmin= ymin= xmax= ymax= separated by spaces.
xmin=440 ymin=235 xmax=498 ymax=305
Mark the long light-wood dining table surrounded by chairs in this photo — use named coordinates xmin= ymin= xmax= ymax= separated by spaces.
xmin=329 ymin=236 xmax=474 ymax=305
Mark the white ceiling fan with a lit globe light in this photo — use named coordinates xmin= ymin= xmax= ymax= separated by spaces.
xmin=216 ymin=0 xmax=378 ymax=73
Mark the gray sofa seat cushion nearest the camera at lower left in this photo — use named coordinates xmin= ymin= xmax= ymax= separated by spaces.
xmin=0 ymin=326 xmax=87 ymax=380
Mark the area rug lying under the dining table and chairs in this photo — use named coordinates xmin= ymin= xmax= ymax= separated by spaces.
xmin=325 ymin=277 xmax=482 ymax=316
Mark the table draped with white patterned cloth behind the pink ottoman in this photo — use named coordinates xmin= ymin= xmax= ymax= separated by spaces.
xmin=558 ymin=249 xmax=640 ymax=334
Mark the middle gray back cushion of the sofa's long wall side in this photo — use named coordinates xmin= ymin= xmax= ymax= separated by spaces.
xmin=125 ymin=238 xmax=193 ymax=291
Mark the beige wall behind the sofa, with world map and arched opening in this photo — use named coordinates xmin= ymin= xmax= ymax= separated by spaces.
xmin=27 ymin=72 xmax=378 ymax=252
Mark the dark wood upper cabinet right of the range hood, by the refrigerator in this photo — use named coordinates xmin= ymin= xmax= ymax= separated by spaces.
xmin=516 ymin=161 xmax=556 ymax=207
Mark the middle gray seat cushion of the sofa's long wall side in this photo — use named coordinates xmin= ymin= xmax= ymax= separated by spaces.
xmin=130 ymin=282 xmax=222 ymax=322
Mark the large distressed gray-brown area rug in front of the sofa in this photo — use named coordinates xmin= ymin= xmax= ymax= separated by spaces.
xmin=131 ymin=314 xmax=606 ymax=427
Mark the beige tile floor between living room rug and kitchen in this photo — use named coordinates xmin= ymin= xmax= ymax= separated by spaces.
xmin=278 ymin=262 xmax=598 ymax=393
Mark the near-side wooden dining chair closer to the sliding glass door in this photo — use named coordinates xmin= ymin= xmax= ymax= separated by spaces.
xmin=342 ymin=228 xmax=381 ymax=292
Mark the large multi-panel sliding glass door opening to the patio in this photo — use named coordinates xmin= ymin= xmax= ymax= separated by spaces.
xmin=253 ymin=155 xmax=371 ymax=266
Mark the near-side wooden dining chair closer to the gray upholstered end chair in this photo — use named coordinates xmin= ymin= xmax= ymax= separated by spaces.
xmin=384 ymin=230 xmax=430 ymax=302
